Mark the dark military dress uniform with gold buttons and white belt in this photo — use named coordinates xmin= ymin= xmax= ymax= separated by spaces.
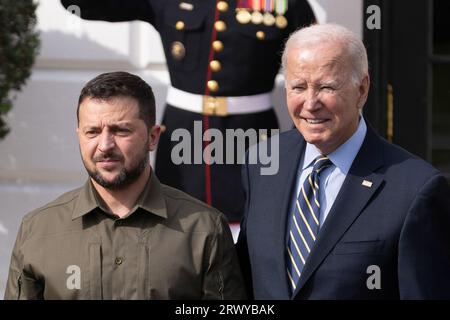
xmin=61 ymin=0 xmax=315 ymax=222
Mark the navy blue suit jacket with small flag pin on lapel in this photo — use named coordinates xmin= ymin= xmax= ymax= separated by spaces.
xmin=237 ymin=127 xmax=450 ymax=299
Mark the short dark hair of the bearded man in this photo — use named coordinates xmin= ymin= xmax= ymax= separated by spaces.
xmin=77 ymin=71 xmax=155 ymax=130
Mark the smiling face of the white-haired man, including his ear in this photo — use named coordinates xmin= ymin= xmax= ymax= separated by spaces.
xmin=285 ymin=43 xmax=369 ymax=154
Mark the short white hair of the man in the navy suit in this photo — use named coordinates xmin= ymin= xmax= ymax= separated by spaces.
xmin=281 ymin=23 xmax=368 ymax=85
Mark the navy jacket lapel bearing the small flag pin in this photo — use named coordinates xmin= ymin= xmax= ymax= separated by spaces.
xmin=293 ymin=126 xmax=383 ymax=297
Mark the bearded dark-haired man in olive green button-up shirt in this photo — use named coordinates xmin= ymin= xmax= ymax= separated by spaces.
xmin=5 ymin=72 xmax=245 ymax=299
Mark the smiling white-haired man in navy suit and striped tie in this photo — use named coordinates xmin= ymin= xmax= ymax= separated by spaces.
xmin=238 ymin=25 xmax=450 ymax=299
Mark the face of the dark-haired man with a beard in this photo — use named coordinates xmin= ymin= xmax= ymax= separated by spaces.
xmin=77 ymin=97 xmax=156 ymax=189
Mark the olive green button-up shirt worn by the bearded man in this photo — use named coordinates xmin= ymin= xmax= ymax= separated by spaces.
xmin=5 ymin=173 xmax=245 ymax=299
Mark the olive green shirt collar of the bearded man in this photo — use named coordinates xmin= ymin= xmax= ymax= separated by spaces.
xmin=72 ymin=171 xmax=167 ymax=220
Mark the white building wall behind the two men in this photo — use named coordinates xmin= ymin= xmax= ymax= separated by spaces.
xmin=0 ymin=0 xmax=363 ymax=297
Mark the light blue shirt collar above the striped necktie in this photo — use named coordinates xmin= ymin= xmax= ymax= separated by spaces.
xmin=302 ymin=116 xmax=367 ymax=174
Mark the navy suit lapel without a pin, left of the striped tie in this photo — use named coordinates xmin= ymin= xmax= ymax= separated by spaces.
xmin=270 ymin=129 xmax=306 ymax=299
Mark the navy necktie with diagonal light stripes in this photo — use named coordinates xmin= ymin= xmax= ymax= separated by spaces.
xmin=286 ymin=156 xmax=332 ymax=292
